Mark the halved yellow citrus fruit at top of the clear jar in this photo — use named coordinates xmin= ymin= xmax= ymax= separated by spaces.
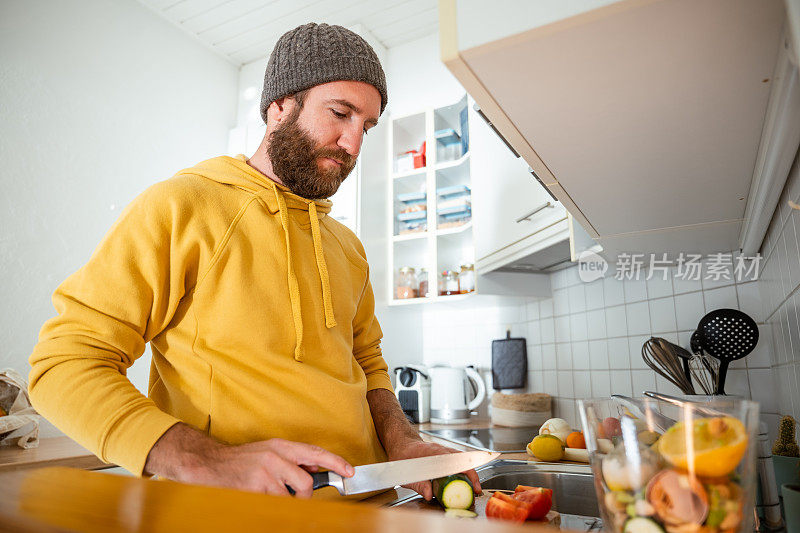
xmin=658 ymin=416 xmax=748 ymax=477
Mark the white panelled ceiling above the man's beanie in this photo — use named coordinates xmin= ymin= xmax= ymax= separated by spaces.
xmin=139 ymin=0 xmax=439 ymax=66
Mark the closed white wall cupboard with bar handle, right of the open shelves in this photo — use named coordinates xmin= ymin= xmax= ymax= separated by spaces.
xmin=470 ymin=102 xmax=569 ymax=273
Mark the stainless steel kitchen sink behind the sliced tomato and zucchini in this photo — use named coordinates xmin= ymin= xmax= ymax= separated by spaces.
xmin=388 ymin=459 xmax=603 ymax=531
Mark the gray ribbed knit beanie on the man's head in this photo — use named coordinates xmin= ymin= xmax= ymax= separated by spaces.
xmin=261 ymin=22 xmax=388 ymax=122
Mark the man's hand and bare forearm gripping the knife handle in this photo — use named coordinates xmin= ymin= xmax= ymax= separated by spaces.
xmin=145 ymin=424 xmax=354 ymax=498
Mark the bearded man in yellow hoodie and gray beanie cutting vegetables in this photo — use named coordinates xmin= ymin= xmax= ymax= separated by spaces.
xmin=30 ymin=24 xmax=480 ymax=499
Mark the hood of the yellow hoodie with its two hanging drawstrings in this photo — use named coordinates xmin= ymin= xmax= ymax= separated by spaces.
xmin=178 ymin=154 xmax=336 ymax=362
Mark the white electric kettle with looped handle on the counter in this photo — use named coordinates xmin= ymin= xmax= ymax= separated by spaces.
xmin=429 ymin=366 xmax=486 ymax=424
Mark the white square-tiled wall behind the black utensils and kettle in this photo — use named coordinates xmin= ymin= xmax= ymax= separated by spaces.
xmin=423 ymin=151 xmax=800 ymax=440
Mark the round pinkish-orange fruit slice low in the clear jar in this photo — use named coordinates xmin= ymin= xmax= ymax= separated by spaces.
xmin=645 ymin=469 xmax=709 ymax=526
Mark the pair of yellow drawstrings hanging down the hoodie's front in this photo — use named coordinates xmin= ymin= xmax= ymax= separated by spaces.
xmin=272 ymin=184 xmax=336 ymax=362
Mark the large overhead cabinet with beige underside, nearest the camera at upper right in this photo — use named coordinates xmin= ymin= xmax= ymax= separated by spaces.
xmin=440 ymin=0 xmax=800 ymax=261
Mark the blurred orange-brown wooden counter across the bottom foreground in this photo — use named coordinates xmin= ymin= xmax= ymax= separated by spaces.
xmin=0 ymin=467 xmax=568 ymax=533
